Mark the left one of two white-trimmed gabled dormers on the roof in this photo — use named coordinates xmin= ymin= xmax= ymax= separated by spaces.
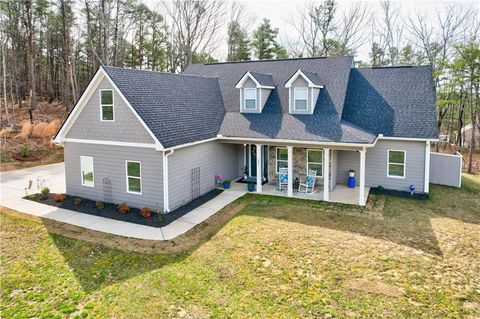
xmin=235 ymin=72 xmax=275 ymax=113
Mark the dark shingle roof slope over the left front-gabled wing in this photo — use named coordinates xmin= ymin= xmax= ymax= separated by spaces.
xmin=103 ymin=67 xmax=225 ymax=148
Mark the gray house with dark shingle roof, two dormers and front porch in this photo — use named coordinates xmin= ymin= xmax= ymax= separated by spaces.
xmin=54 ymin=57 xmax=438 ymax=212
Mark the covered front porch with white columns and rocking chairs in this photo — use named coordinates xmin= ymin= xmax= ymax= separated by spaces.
xmin=225 ymin=141 xmax=370 ymax=206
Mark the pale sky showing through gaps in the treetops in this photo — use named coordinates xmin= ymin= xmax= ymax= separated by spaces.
xmin=147 ymin=0 xmax=480 ymax=61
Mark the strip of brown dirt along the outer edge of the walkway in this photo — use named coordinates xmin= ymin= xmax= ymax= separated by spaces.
xmin=0 ymin=202 xmax=245 ymax=254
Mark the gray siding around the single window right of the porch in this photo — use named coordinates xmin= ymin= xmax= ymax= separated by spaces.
xmin=366 ymin=140 xmax=425 ymax=193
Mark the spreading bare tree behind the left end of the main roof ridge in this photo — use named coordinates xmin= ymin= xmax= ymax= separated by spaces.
xmin=164 ymin=0 xmax=225 ymax=71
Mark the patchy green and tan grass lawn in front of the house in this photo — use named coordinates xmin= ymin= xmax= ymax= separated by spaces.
xmin=0 ymin=176 xmax=480 ymax=318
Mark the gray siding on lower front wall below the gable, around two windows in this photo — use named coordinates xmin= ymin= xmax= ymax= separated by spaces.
xmin=64 ymin=142 xmax=163 ymax=210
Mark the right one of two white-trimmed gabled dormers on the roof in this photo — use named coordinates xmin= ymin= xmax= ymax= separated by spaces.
xmin=285 ymin=70 xmax=323 ymax=114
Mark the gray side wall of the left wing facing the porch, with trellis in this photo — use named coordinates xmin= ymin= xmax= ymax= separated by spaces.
xmin=168 ymin=141 xmax=239 ymax=210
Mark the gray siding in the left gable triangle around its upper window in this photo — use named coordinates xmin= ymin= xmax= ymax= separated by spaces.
xmin=66 ymin=78 xmax=154 ymax=143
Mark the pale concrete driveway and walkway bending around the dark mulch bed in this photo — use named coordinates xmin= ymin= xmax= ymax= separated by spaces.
xmin=0 ymin=163 xmax=246 ymax=240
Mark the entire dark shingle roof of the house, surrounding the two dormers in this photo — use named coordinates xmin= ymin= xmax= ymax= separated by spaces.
xmin=93 ymin=57 xmax=438 ymax=147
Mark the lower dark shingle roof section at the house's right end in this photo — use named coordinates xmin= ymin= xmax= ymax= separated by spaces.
xmin=342 ymin=66 xmax=438 ymax=139
